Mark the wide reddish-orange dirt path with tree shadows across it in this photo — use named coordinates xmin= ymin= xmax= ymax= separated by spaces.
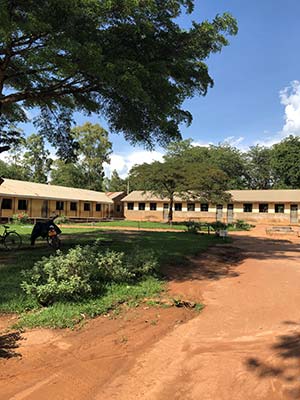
xmin=0 ymin=230 xmax=300 ymax=400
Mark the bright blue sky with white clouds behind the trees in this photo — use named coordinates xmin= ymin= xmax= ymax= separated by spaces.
xmin=18 ymin=0 xmax=300 ymax=177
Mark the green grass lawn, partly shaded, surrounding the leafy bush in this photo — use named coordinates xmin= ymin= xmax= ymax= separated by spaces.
xmin=0 ymin=226 xmax=225 ymax=328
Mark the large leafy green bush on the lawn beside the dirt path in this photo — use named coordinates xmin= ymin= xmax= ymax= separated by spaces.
xmin=21 ymin=243 xmax=158 ymax=305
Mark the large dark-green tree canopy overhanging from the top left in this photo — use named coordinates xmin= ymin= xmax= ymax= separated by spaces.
xmin=0 ymin=0 xmax=237 ymax=157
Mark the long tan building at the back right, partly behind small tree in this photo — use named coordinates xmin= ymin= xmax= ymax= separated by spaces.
xmin=122 ymin=189 xmax=300 ymax=224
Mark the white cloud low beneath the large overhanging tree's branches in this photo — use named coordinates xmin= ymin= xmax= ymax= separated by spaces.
xmin=104 ymin=150 xmax=164 ymax=178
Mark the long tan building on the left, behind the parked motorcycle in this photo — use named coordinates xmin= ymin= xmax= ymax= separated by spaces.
xmin=0 ymin=179 xmax=114 ymax=220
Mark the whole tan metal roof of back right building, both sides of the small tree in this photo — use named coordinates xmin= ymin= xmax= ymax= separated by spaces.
xmin=122 ymin=191 xmax=300 ymax=203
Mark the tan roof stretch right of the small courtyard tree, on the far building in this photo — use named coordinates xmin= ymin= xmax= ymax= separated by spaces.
xmin=230 ymin=189 xmax=300 ymax=203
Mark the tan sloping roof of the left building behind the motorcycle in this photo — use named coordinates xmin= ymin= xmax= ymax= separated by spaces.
xmin=0 ymin=179 xmax=113 ymax=203
